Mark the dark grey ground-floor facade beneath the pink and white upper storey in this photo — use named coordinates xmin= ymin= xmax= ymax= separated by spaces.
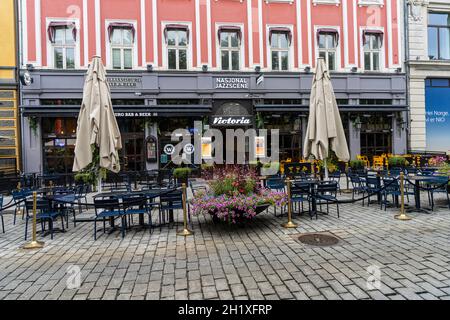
xmin=20 ymin=70 xmax=407 ymax=173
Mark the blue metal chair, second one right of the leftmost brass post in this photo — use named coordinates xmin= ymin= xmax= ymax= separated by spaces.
xmin=94 ymin=198 xmax=126 ymax=240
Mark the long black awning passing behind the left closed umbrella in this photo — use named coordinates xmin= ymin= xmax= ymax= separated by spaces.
xmin=20 ymin=105 xmax=212 ymax=117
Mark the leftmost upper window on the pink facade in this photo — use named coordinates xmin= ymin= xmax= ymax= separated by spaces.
xmin=47 ymin=22 xmax=77 ymax=69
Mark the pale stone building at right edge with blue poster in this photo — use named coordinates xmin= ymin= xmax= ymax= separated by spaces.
xmin=407 ymin=0 xmax=450 ymax=153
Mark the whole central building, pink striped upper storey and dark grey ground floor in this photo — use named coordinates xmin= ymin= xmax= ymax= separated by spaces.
xmin=21 ymin=0 xmax=407 ymax=172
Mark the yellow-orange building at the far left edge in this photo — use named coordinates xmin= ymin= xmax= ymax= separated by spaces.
xmin=0 ymin=0 xmax=20 ymax=174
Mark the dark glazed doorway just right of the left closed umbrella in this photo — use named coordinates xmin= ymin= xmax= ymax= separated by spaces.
xmin=120 ymin=132 xmax=145 ymax=171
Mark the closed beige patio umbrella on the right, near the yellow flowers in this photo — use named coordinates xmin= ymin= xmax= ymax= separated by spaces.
xmin=303 ymin=58 xmax=350 ymax=178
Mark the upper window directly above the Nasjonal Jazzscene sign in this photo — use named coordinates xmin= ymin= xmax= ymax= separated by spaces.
xmin=219 ymin=26 xmax=242 ymax=70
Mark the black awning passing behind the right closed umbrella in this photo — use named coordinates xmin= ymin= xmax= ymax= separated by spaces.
xmin=255 ymin=104 xmax=408 ymax=112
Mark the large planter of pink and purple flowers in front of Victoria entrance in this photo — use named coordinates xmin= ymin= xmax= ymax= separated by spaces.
xmin=191 ymin=166 xmax=287 ymax=224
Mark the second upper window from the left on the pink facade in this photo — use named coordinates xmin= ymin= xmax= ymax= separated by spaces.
xmin=108 ymin=23 xmax=136 ymax=70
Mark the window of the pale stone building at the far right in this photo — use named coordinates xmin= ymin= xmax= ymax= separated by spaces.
xmin=428 ymin=12 xmax=450 ymax=60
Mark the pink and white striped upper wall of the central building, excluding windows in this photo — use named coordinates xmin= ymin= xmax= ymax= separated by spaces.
xmin=21 ymin=0 xmax=403 ymax=72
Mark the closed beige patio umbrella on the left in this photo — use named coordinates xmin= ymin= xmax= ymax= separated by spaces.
xmin=73 ymin=57 xmax=122 ymax=172
